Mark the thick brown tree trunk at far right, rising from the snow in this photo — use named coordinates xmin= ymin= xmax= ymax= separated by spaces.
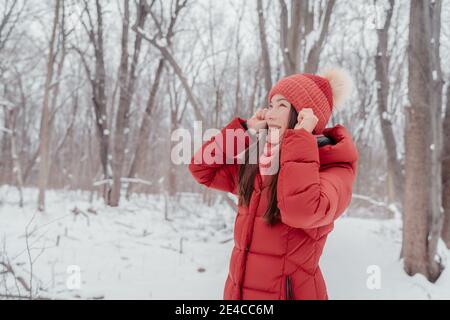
xmin=403 ymin=0 xmax=442 ymax=282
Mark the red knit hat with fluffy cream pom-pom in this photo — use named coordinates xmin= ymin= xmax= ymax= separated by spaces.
xmin=268 ymin=68 xmax=352 ymax=134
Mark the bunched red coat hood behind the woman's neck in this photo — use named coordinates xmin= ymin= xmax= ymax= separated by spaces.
xmin=319 ymin=124 xmax=359 ymax=167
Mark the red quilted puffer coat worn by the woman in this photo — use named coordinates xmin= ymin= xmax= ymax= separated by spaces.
xmin=189 ymin=118 xmax=359 ymax=300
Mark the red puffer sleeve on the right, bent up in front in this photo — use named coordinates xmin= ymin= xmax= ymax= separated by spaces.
xmin=277 ymin=128 xmax=357 ymax=229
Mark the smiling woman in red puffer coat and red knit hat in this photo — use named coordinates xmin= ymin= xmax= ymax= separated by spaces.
xmin=189 ymin=69 xmax=358 ymax=300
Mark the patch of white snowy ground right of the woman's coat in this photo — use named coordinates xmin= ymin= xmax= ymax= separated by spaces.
xmin=321 ymin=218 xmax=450 ymax=299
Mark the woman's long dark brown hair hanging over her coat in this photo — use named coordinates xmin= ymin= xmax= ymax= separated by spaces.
xmin=238 ymin=106 xmax=298 ymax=225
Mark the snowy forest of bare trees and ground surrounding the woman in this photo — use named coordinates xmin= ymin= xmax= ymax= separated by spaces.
xmin=0 ymin=0 xmax=450 ymax=299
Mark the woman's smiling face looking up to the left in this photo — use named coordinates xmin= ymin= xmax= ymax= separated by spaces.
xmin=266 ymin=94 xmax=291 ymax=136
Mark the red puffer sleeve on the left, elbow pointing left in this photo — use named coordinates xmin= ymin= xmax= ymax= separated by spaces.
xmin=189 ymin=117 xmax=250 ymax=194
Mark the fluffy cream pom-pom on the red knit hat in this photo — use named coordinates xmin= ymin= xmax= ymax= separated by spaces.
xmin=320 ymin=67 xmax=353 ymax=109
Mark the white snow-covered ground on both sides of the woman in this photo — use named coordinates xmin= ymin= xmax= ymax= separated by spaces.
xmin=0 ymin=186 xmax=450 ymax=299
